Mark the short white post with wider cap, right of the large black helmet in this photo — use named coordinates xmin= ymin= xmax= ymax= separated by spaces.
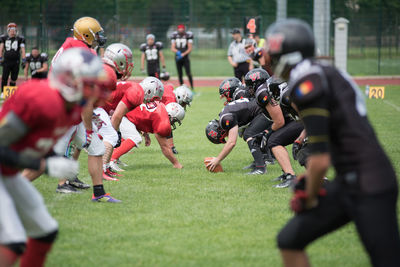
xmin=334 ymin=18 xmax=349 ymax=71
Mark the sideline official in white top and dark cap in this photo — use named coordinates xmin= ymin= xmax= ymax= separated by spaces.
xmin=228 ymin=28 xmax=251 ymax=81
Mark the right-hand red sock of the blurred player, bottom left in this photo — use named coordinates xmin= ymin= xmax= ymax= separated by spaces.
xmin=20 ymin=238 xmax=53 ymax=267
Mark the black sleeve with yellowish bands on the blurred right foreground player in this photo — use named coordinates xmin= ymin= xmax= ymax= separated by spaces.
xmin=290 ymin=73 xmax=330 ymax=154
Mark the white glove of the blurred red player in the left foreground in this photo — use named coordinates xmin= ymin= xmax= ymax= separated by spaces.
xmin=45 ymin=156 xmax=79 ymax=179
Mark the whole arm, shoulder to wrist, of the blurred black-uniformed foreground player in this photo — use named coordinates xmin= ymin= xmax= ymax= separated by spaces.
xmin=292 ymin=74 xmax=330 ymax=208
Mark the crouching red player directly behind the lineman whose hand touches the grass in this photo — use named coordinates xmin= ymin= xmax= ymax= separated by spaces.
xmin=105 ymin=77 xmax=164 ymax=170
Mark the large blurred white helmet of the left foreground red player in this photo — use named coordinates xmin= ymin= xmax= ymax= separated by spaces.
xmin=49 ymin=48 xmax=106 ymax=102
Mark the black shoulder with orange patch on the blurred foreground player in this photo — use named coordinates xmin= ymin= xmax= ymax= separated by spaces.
xmin=289 ymin=69 xmax=328 ymax=108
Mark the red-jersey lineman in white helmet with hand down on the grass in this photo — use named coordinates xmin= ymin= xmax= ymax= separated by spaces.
xmin=112 ymin=101 xmax=185 ymax=169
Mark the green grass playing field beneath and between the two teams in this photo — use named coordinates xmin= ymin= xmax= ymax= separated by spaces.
xmin=34 ymin=87 xmax=400 ymax=267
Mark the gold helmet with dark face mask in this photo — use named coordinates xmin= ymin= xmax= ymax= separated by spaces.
xmin=72 ymin=17 xmax=107 ymax=47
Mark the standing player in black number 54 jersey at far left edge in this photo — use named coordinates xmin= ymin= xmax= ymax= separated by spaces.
xmin=0 ymin=22 xmax=26 ymax=94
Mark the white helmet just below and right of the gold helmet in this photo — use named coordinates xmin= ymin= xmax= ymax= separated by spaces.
xmin=103 ymin=43 xmax=133 ymax=80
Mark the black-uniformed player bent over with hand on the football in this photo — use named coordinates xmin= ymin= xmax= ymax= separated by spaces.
xmin=206 ymin=98 xmax=272 ymax=175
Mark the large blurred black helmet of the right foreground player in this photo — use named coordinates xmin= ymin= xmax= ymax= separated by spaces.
xmin=266 ymin=19 xmax=315 ymax=80
